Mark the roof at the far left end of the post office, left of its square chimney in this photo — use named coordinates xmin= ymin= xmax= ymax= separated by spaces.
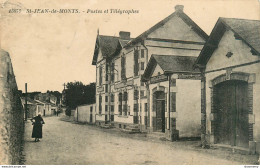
xmin=92 ymin=35 xmax=119 ymax=65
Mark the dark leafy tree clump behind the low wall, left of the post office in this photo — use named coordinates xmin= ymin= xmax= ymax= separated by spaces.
xmin=65 ymin=81 xmax=96 ymax=109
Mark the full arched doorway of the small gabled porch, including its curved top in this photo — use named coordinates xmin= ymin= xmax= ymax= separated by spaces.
xmin=153 ymin=91 xmax=165 ymax=132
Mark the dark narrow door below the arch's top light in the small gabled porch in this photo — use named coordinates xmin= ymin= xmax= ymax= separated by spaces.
xmin=156 ymin=100 xmax=165 ymax=132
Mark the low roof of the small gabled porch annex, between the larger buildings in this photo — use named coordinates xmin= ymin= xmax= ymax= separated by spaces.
xmin=143 ymin=55 xmax=199 ymax=80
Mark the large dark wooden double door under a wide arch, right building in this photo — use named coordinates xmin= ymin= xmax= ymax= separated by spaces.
xmin=213 ymin=80 xmax=249 ymax=148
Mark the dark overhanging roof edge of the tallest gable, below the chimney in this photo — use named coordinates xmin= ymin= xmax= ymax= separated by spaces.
xmin=125 ymin=11 xmax=208 ymax=47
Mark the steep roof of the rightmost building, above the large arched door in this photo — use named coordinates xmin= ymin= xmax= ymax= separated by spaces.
xmin=196 ymin=17 xmax=260 ymax=65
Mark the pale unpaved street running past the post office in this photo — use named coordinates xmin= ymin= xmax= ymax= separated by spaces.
xmin=24 ymin=116 xmax=256 ymax=165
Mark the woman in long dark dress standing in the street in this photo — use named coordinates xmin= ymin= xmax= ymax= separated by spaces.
xmin=31 ymin=114 xmax=45 ymax=142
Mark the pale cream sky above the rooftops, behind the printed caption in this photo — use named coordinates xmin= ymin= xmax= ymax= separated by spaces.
xmin=0 ymin=0 xmax=260 ymax=92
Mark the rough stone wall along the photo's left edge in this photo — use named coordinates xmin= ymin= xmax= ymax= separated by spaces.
xmin=0 ymin=50 xmax=24 ymax=165
